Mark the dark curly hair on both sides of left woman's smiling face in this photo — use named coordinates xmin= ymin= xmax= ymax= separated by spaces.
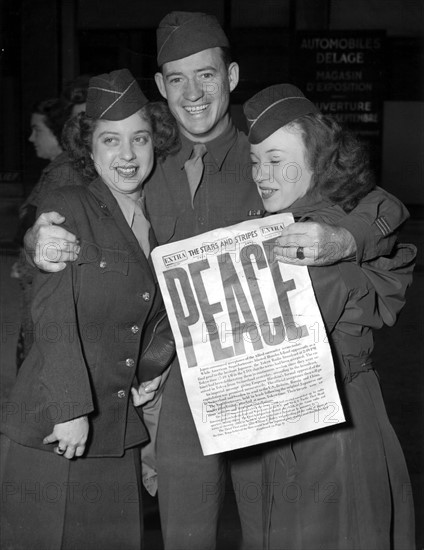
xmin=62 ymin=101 xmax=181 ymax=180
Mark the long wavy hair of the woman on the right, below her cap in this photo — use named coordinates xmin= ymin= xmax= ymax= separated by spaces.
xmin=287 ymin=114 xmax=375 ymax=212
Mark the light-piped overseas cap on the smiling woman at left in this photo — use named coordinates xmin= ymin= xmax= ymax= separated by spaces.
xmin=85 ymin=69 xmax=148 ymax=120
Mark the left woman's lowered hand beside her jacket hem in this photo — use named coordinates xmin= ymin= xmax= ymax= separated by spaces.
xmin=43 ymin=416 xmax=90 ymax=458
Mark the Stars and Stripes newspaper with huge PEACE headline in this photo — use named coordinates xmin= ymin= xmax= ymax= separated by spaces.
xmin=152 ymin=214 xmax=344 ymax=455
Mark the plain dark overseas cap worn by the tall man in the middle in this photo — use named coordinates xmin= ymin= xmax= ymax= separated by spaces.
xmin=156 ymin=11 xmax=230 ymax=67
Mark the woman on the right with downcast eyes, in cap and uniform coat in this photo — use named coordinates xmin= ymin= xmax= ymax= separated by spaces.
xmin=244 ymin=84 xmax=415 ymax=550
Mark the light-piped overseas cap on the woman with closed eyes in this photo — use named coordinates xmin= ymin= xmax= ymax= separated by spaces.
xmin=243 ymin=84 xmax=320 ymax=144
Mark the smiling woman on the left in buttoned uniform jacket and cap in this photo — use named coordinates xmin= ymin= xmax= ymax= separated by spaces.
xmin=1 ymin=69 xmax=178 ymax=550
